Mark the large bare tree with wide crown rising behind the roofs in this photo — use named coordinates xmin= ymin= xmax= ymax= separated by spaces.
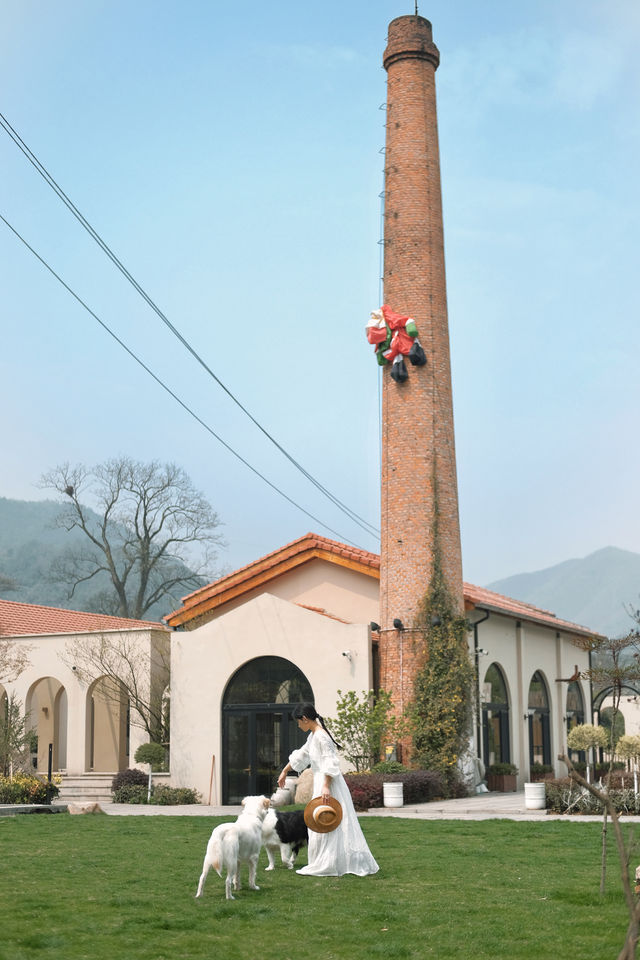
xmin=40 ymin=457 xmax=223 ymax=620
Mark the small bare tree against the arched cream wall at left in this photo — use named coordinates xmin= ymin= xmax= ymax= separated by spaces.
xmin=61 ymin=631 xmax=170 ymax=743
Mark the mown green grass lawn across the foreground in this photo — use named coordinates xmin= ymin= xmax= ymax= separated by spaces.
xmin=0 ymin=814 xmax=627 ymax=960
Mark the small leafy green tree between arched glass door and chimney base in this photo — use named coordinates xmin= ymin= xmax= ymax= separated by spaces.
xmin=330 ymin=690 xmax=403 ymax=773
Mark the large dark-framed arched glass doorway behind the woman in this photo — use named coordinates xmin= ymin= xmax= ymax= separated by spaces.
xmin=222 ymin=657 xmax=313 ymax=804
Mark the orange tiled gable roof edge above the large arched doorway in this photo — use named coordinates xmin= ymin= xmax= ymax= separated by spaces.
xmin=164 ymin=533 xmax=380 ymax=627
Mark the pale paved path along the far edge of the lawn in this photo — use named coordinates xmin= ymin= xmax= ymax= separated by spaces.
xmin=5 ymin=792 xmax=640 ymax=823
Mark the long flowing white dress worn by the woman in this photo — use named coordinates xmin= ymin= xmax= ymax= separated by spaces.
xmin=289 ymin=729 xmax=380 ymax=877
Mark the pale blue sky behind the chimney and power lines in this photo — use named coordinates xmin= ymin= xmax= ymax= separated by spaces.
xmin=0 ymin=0 xmax=640 ymax=584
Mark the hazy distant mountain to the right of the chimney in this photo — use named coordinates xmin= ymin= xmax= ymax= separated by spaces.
xmin=487 ymin=547 xmax=640 ymax=637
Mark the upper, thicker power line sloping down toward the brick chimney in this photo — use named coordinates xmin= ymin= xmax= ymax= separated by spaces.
xmin=0 ymin=113 xmax=380 ymax=536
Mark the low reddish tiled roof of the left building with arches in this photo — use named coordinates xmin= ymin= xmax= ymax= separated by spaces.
xmin=0 ymin=600 xmax=166 ymax=637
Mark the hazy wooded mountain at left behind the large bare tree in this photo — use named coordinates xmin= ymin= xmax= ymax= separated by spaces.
xmin=0 ymin=497 xmax=204 ymax=620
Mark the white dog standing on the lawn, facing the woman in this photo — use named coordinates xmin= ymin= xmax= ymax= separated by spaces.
xmin=196 ymin=797 xmax=270 ymax=900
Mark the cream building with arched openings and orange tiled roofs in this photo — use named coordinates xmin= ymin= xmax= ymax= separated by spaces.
xmin=0 ymin=534 xmax=593 ymax=803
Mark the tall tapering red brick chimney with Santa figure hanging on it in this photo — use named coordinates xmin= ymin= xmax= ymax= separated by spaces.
xmin=379 ymin=16 xmax=463 ymax=708
